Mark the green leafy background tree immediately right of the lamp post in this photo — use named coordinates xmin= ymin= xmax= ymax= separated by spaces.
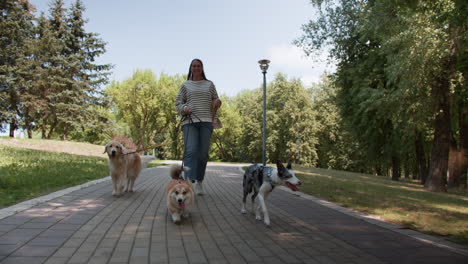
xmin=267 ymin=74 xmax=318 ymax=166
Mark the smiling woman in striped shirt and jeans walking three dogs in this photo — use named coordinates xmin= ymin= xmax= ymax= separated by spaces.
xmin=176 ymin=59 xmax=221 ymax=195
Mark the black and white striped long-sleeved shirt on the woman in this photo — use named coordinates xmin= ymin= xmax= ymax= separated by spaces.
xmin=176 ymin=80 xmax=218 ymax=125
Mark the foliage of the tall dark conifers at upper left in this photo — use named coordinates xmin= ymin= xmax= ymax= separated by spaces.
xmin=0 ymin=0 xmax=111 ymax=140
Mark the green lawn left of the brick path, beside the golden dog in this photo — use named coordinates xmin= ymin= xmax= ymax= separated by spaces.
xmin=0 ymin=145 xmax=109 ymax=208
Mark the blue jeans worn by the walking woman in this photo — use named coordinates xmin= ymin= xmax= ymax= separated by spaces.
xmin=182 ymin=122 xmax=213 ymax=181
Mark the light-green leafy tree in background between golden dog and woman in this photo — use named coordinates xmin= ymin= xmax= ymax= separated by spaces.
xmin=105 ymin=70 xmax=182 ymax=152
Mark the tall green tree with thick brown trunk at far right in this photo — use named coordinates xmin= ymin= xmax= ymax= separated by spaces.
xmin=370 ymin=0 xmax=468 ymax=191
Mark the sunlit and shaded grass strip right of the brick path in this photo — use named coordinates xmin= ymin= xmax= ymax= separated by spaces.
xmin=294 ymin=166 xmax=468 ymax=244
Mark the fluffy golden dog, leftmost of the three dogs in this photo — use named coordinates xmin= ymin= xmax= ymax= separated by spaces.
xmin=104 ymin=136 xmax=142 ymax=197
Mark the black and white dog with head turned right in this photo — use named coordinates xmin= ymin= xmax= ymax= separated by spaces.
xmin=241 ymin=161 xmax=301 ymax=225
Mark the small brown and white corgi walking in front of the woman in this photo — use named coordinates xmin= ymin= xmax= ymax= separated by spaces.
xmin=166 ymin=165 xmax=195 ymax=224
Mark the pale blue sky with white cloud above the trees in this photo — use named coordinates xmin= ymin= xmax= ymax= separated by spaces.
xmin=30 ymin=0 xmax=334 ymax=96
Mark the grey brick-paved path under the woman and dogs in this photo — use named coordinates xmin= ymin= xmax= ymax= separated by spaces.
xmin=0 ymin=164 xmax=468 ymax=264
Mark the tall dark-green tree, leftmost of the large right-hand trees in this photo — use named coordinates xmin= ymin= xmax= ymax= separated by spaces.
xmin=296 ymin=1 xmax=401 ymax=180
